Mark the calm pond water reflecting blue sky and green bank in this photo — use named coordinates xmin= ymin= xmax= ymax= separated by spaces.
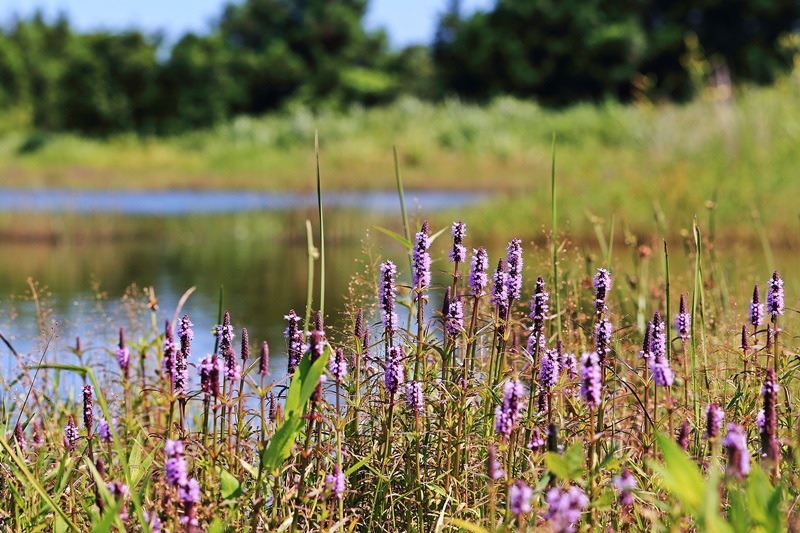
xmin=0 ymin=189 xmax=484 ymax=394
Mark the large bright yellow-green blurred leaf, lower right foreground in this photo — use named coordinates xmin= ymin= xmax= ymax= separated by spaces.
xmin=656 ymin=433 xmax=705 ymax=515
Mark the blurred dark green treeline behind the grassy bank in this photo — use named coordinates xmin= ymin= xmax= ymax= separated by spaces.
xmin=0 ymin=0 xmax=800 ymax=135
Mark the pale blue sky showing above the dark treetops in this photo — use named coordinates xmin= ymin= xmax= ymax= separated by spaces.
xmin=0 ymin=0 xmax=494 ymax=46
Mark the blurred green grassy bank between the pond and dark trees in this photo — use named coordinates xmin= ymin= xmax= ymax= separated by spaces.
xmin=0 ymin=75 xmax=800 ymax=242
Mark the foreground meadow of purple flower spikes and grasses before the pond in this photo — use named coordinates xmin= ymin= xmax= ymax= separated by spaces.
xmin=0 ymin=152 xmax=800 ymax=532
